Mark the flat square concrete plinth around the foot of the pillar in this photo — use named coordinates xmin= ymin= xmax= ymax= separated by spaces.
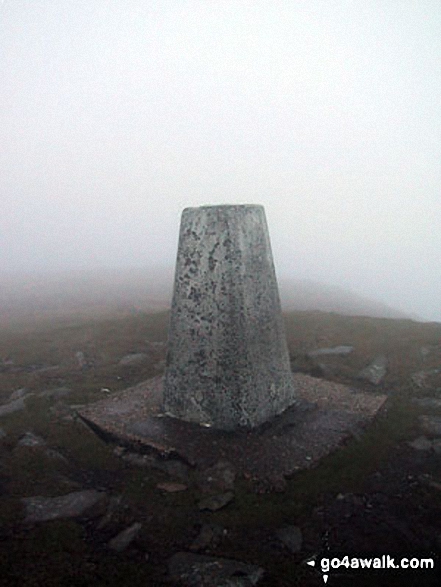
xmin=79 ymin=374 xmax=386 ymax=486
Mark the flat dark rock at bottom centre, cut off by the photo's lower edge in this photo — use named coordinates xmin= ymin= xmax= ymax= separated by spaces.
xmin=168 ymin=552 xmax=264 ymax=587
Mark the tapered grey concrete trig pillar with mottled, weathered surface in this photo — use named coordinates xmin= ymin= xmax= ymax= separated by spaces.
xmin=164 ymin=205 xmax=295 ymax=430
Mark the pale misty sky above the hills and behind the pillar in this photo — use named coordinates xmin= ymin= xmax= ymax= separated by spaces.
xmin=0 ymin=0 xmax=441 ymax=321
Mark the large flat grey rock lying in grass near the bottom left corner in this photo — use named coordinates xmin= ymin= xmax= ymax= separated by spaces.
xmin=21 ymin=489 xmax=106 ymax=522
